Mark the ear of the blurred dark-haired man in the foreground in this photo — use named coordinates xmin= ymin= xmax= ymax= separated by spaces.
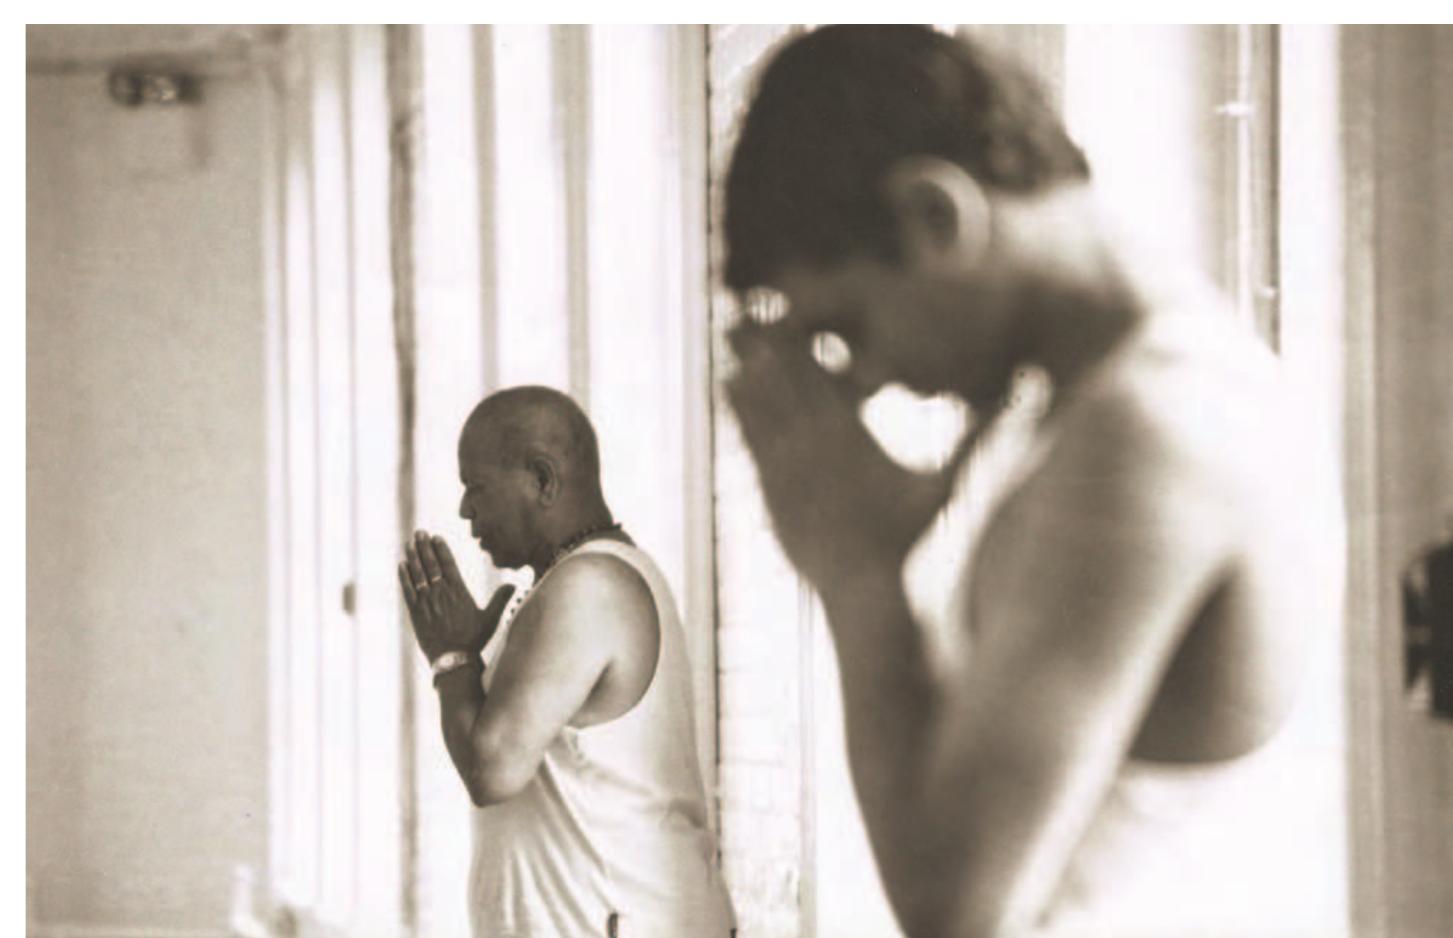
xmin=883 ymin=157 xmax=992 ymax=273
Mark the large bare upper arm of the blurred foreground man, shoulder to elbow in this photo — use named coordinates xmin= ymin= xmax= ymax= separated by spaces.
xmin=928 ymin=389 xmax=1234 ymax=934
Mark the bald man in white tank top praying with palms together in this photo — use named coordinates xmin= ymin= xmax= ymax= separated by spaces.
xmin=398 ymin=386 xmax=732 ymax=938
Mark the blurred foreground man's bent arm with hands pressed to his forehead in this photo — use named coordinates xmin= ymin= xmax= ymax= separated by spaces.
xmin=727 ymin=321 xmax=1234 ymax=938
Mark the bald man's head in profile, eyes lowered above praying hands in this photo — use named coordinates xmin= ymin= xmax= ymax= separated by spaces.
xmin=459 ymin=386 xmax=604 ymax=568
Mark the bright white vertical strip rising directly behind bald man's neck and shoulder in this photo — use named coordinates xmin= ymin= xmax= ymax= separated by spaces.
xmin=586 ymin=26 xmax=684 ymax=624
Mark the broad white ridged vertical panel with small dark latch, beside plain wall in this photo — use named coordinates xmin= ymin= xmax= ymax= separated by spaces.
xmin=263 ymin=26 xmax=402 ymax=938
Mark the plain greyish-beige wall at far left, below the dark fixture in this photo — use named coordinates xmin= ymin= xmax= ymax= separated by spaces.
xmin=26 ymin=30 xmax=267 ymax=935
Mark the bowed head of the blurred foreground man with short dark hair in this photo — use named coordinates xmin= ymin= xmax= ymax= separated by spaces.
xmin=725 ymin=26 xmax=1090 ymax=406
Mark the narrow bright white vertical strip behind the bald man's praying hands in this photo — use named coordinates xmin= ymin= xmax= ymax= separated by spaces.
xmin=411 ymin=26 xmax=485 ymax=937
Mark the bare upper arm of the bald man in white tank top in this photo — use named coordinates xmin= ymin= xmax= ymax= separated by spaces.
xmin=474 ymin=556 xmax=642 ymax=800
